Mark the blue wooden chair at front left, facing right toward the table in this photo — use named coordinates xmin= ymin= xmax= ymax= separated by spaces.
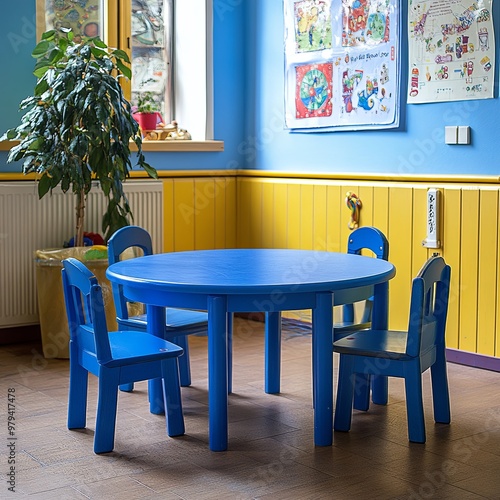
xmin=62 ymin=258 xmax=184 ymax=453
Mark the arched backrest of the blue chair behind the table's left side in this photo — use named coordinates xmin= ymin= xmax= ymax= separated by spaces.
xmin=108 ymin=226 xmax=153 ymax=319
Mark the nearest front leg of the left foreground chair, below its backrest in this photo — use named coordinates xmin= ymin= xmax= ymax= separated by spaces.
xmin=94 ymin=366 xmax=120 ymax=453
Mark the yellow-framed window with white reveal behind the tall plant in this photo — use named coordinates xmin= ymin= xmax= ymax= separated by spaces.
xmin=37 ymin=0 xmax=213 ymax=141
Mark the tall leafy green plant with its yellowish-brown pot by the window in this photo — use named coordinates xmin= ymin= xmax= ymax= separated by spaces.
xmin=0 ymin=29 xmax=157 ymax=357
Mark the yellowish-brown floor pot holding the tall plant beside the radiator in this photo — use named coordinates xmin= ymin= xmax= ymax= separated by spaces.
xmin=35 ymin=247 xmax=117 ymax=359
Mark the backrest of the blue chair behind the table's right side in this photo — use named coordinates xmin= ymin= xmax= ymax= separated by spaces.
xmin=343 ymin=226 xmax=389 ymax=324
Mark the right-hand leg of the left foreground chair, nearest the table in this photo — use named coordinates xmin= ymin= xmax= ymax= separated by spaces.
xmin=161 ymin=358 xmax=185 ymax=436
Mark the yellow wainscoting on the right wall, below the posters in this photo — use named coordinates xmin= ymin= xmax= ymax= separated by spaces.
xmin=236 ymin=176 xmax=500 ymax=357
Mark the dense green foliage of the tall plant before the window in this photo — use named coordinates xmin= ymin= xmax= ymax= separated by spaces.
xmin=3 ymin=30 xmax=157 ymax=246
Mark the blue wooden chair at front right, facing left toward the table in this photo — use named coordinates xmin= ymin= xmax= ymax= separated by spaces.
xmin=333 ymin=256 xmax=451 ymax=443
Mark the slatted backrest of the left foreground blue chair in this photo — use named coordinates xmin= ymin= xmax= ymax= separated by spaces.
xmin=62 ymin=258 xmax=111 ymax=364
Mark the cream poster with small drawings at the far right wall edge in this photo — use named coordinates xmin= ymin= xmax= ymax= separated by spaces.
xmin=408 ymin=0 xmax=495 ymax=104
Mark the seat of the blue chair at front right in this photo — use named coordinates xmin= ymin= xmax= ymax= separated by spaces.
xmin=333 ymin=330 xmax=410 ymax=359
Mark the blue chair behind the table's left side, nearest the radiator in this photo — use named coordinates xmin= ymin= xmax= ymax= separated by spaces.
xmin=108 ymin=226 xmax=208 ymax=391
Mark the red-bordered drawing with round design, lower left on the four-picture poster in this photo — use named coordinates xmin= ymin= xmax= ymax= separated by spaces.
xmin=295 ymin=63 xmax=333 ymax=118
